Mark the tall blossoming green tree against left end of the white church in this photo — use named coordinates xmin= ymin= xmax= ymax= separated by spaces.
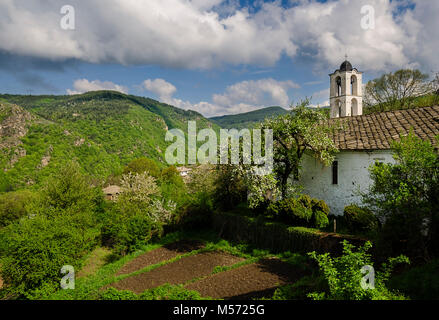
xmin=261 ymin=99 xmax=338 ymax=197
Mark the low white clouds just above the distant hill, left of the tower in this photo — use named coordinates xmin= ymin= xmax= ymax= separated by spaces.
xmin=142 ymin=78 xmax=300 ymax=117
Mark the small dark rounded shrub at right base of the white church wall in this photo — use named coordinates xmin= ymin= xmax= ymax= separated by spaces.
xmin=344 ymin=205 xmax=378 ymax=233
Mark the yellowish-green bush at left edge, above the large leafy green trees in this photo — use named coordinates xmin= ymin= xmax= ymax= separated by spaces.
xmin=0 ymin=190 xmax=38 ymax=227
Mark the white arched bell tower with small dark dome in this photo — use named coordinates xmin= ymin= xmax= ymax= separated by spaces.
xmin=329 ymin=57 xmax=363 ymax=118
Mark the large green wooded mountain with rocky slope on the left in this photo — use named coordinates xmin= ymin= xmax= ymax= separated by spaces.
xmin=0 ymin=91 xmax=219 ymax=192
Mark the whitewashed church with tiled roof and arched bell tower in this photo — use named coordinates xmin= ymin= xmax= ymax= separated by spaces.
xmin=298 ymin=60 xmax=439 ymax=215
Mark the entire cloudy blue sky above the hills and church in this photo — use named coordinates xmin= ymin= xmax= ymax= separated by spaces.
xmin=0 ymin=0 xmax=439 ymax=117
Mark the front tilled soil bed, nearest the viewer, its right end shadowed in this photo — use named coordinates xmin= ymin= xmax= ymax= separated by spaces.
xmin=186 ymin=259 xmax=307 ymax=300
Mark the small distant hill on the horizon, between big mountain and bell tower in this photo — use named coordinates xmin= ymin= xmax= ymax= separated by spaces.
xmin=209 ymin=107 xmax=288 ymax=129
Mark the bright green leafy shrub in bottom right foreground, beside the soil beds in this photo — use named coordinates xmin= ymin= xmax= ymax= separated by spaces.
xmin=308 ymin=241 xmax=409 ymax=300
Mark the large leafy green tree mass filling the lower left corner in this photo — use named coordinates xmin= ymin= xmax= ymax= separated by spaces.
xmin=0 ymin=163 xmax=103 ymax=298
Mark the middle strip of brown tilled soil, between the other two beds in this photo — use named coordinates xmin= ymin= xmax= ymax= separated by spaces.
xmin=110 ymin=252 xmax=244 ymax=294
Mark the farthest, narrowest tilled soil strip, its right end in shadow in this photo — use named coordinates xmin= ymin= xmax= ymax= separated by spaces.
xmin=116 ymin=240 xmax=204 ymax=276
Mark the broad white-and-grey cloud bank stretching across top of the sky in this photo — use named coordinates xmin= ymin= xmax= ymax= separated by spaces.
xmin=0 ymin=0 xmax=439 ymax=71
